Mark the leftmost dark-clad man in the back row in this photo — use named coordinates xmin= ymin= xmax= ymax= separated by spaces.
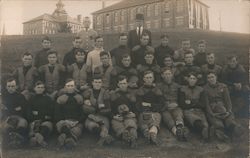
xmin=34 ymin=36 xmax=51 ymax=68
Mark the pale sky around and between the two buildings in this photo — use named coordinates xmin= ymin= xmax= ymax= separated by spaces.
xmin=0 ymin=0 xmax=250 ymax=35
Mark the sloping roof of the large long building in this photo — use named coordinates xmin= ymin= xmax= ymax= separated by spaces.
xmin=92 ymin=0 xmax=209 ymax=14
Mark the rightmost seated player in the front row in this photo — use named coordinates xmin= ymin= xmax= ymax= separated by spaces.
xmin=204 ymin=72 xmax=242 ymax=141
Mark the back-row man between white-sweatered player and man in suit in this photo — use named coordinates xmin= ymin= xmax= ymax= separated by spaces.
xmin=110 ymin=33 xmax=130 ymax=66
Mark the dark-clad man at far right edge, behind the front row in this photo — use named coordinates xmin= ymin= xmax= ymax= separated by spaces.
xmin=221 ymin=56 xmax=250 ymax=117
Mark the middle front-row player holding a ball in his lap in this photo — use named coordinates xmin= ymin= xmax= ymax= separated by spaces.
xmin=110 ymin=76 xmax=137 ymax=148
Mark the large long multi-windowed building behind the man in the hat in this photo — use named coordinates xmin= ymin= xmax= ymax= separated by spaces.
xmin=92 ymin=0 xmax=209 ymax=33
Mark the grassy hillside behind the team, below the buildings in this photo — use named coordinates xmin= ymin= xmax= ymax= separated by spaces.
xmin=1 ymin=29 xmax=250 ymax=73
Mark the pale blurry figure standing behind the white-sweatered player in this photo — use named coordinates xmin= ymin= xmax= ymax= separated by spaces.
xmin=77 ymin=16 xmax=97 ymax=52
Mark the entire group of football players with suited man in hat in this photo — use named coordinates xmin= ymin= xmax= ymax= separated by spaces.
xmin=2 ymin=15 xmax=249 ymax=148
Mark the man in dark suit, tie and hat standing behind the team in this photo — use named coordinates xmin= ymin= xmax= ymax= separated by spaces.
xmin=128 ymin=14 xmax=151 ymax=51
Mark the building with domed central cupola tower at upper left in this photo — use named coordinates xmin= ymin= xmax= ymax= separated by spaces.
xmin=23 ymin=0 xmax=83 ymax=35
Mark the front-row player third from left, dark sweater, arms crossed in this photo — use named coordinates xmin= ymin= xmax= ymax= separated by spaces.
xmin=54 ymin=79 xmax=84 ymax=149
